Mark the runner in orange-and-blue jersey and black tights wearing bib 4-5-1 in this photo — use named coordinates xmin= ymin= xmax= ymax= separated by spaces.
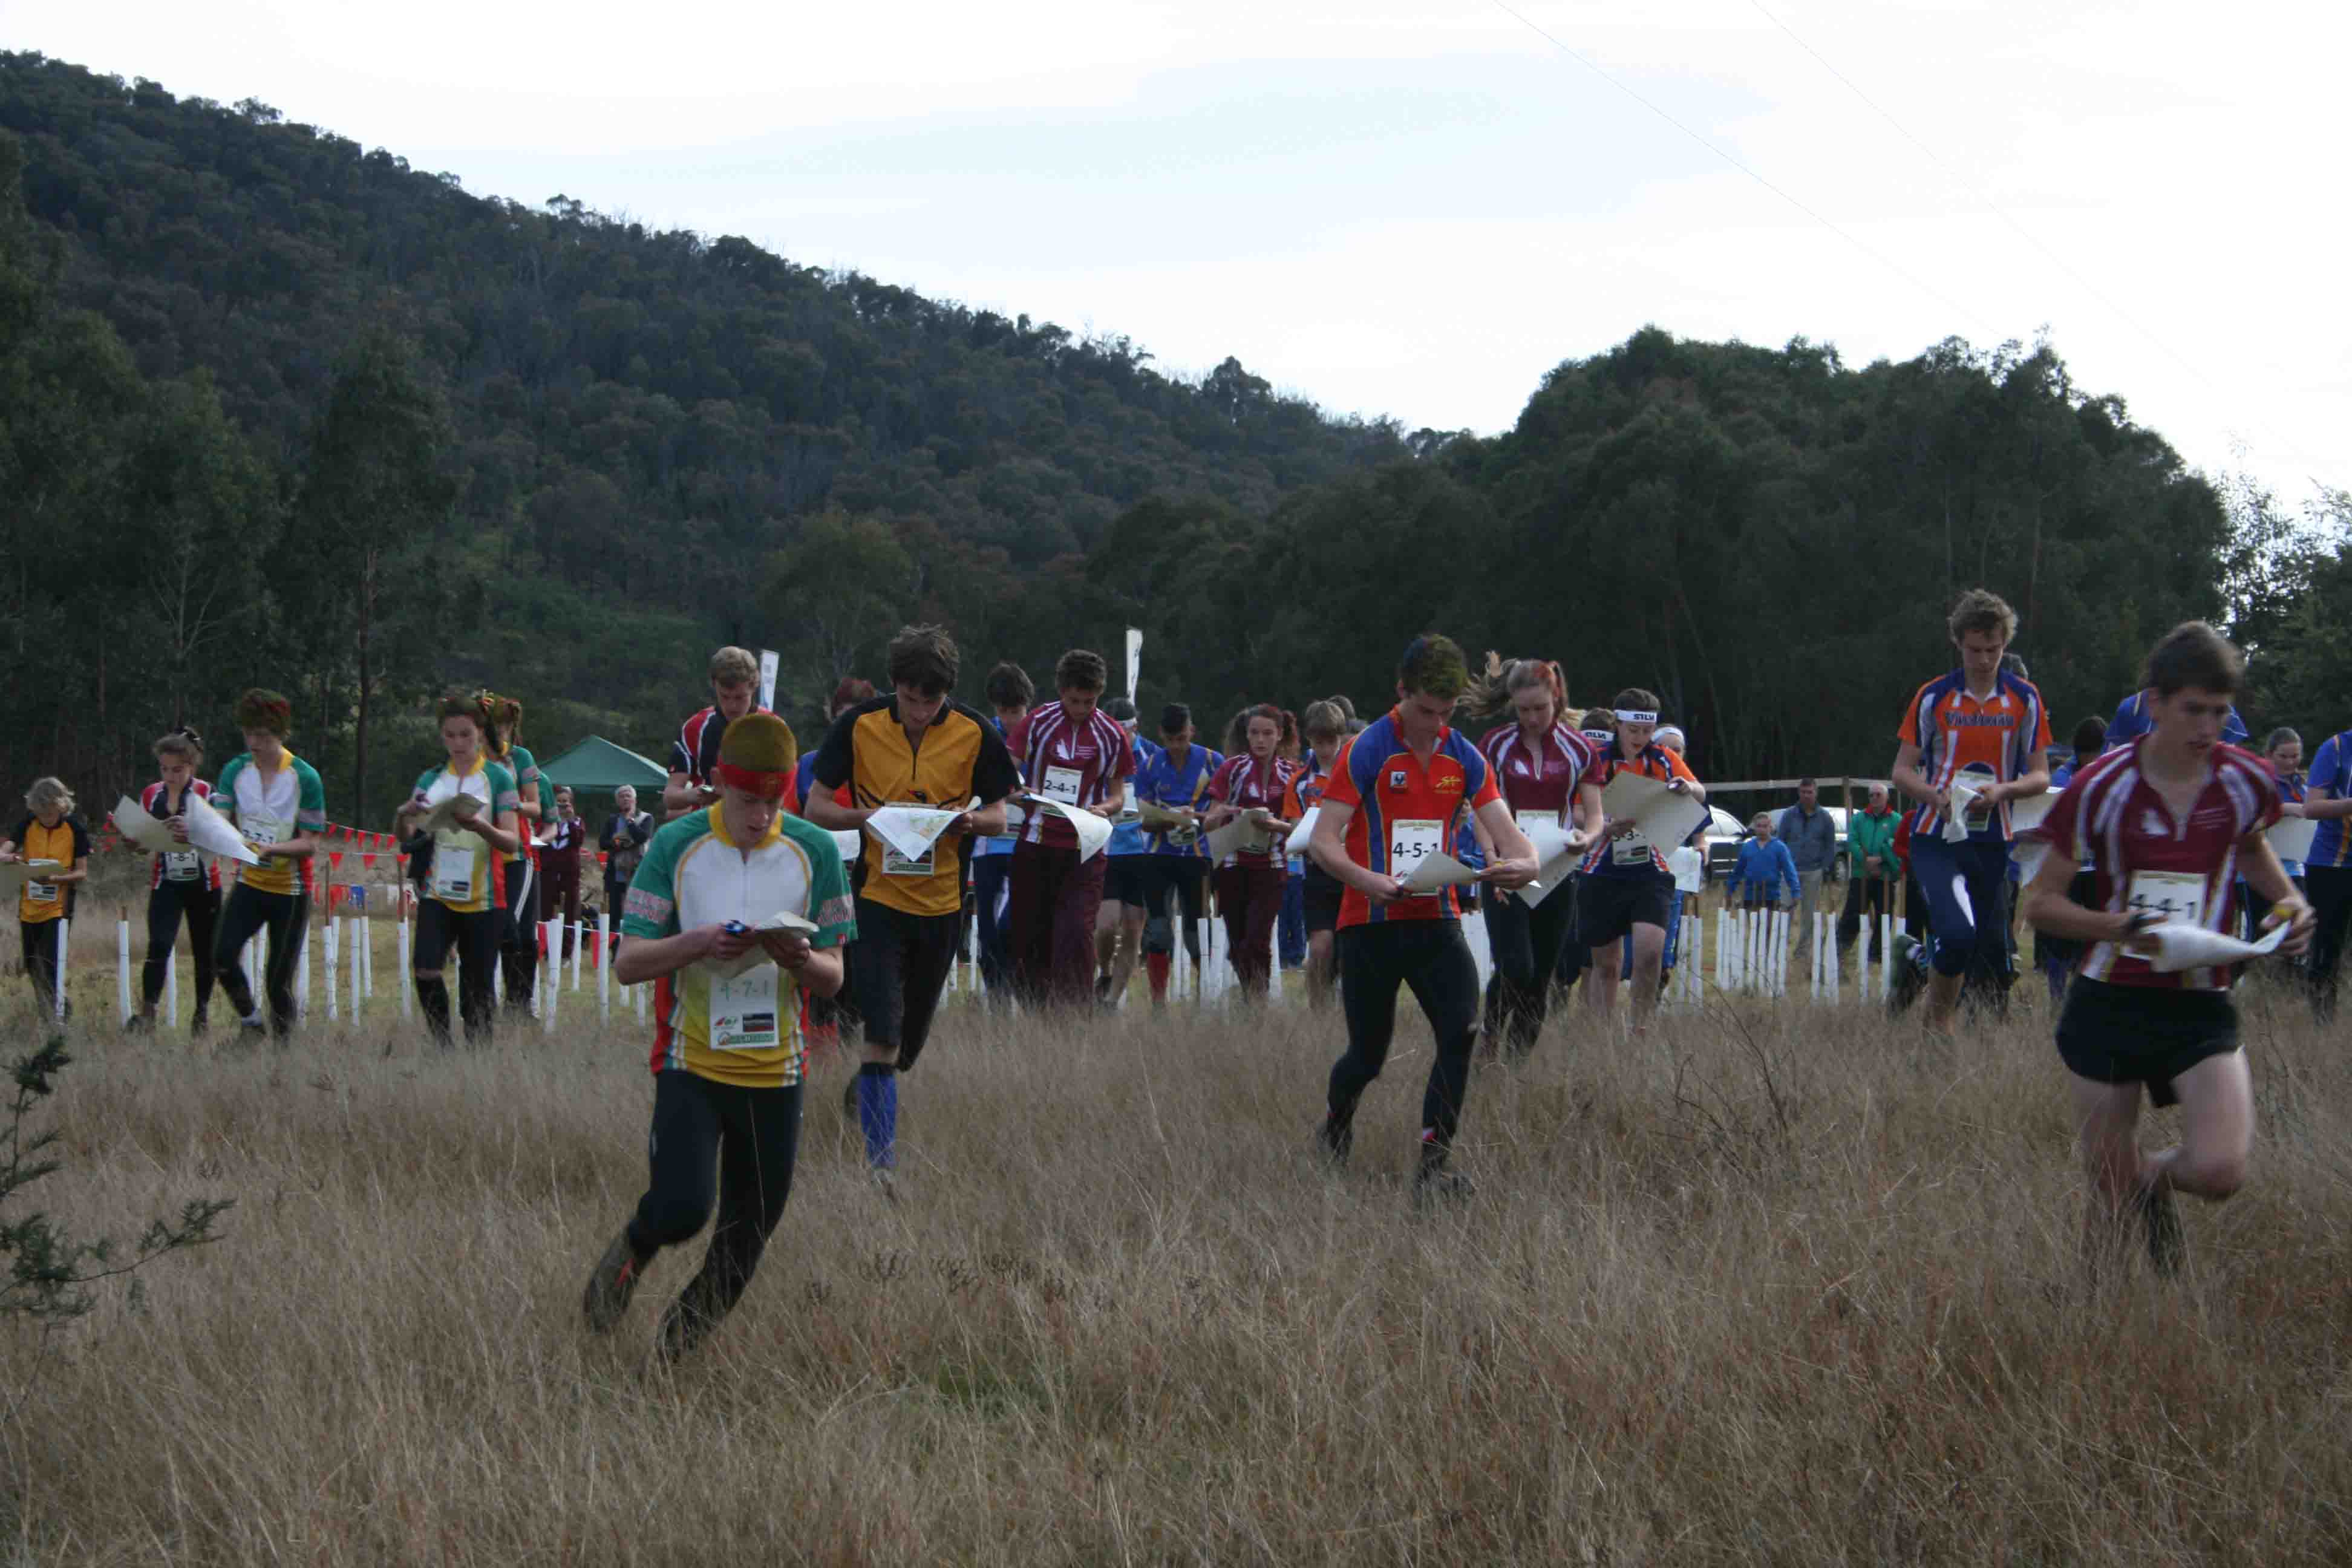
xmin=1308 ymin=632 xmax=1536 ymax=1201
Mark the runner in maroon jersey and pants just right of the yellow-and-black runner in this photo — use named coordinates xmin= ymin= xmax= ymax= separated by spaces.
xmin=1004 ymin=649 xmax=1136 ymax=1006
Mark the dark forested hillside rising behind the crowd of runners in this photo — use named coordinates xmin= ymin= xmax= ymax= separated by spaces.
xmin=0 ymin=54 xmax=2352 ymax=818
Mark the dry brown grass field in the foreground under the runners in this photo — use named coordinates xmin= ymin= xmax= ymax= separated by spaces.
xmin=0 ymin=926 xmax=2352 ymax=1566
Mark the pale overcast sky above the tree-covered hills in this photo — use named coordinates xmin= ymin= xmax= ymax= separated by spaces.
xmin=0 ymin=0 xmax=2352 ymax=503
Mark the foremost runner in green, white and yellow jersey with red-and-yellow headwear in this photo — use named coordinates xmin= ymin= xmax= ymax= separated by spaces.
xmin=581 ymin=712 xmax=856 ymax=1361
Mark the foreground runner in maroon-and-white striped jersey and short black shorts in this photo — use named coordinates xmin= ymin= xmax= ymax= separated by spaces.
xmin=2025 ymin=621 xmax=2312 ymax=1272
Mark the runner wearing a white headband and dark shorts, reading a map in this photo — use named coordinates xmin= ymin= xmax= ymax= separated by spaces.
xmin=1576 ymin=687 xmax=1708 ymax=1034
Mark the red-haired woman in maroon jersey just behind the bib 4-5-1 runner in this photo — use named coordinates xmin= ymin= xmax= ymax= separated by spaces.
xmin=1470 ymin=653 xmax=1602 ymax=1058
